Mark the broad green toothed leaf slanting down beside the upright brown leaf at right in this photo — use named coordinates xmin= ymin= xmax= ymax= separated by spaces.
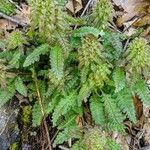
xmin=116 ymin=87 xmax=136 ymax=123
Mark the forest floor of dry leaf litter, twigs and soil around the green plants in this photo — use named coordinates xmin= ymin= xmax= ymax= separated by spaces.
xmin=0 ymin=0 xmax=150 ymax=150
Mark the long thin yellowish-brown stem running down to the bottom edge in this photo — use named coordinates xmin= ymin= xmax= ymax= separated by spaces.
xmin=33 ymin=69 xmax=52 ymax=150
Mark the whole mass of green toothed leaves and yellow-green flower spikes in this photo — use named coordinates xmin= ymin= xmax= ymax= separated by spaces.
xmin=0 ymin=0 xmax=150 ymax=150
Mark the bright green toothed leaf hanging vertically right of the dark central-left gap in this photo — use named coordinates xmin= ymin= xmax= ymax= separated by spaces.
xmin=50 ymin=46 xmax=64 ymax=79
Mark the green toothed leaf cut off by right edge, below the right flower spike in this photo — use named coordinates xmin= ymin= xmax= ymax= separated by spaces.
xmin=132 ymin=80 xmax=150 ymax=106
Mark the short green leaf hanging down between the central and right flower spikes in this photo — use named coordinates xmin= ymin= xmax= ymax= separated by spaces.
xmin=113 ymin=67 xmax=125 ymax=93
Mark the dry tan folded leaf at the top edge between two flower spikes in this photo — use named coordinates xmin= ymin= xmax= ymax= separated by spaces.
xmin=66 ymin=0 xmax=83 ymax=14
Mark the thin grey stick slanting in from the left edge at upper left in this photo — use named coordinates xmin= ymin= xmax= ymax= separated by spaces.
xmin=0 ymin=12 xmax=28 ymax=27
